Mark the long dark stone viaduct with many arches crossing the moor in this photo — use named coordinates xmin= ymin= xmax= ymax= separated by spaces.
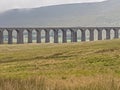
xmin=0 ymin=27 xmax=120 ymax=44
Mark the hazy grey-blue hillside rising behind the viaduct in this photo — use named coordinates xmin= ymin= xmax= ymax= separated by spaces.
xmin=0 ymin=0 xmax=120 ymax=27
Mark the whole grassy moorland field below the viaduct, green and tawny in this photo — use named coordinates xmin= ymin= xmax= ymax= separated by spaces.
xmin=0 ymin=40 xmax=120 ymax=90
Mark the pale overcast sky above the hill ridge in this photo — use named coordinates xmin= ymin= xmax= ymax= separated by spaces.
xmin=0 ymin=0 xmax=104 ymax=12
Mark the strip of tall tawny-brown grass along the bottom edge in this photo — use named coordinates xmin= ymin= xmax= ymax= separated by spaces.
xmin=0 ymin=76 xmax=120 ymax=90
